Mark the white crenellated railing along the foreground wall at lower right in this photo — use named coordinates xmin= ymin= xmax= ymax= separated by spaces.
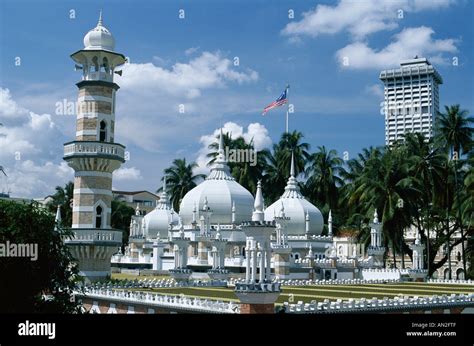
xmin=283 ymin=293 xmax=474 ymax=314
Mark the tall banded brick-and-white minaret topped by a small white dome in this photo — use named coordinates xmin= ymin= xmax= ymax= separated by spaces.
xmin=64 ymin=12 xmax=126 ymax=281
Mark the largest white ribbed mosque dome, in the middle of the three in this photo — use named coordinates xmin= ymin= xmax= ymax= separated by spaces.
xmin=179 ymin=130 xmax=254 ymax=224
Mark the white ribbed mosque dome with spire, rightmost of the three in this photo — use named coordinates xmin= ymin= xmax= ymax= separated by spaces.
xmin=265 ymin=155 xmax=324 ymax=235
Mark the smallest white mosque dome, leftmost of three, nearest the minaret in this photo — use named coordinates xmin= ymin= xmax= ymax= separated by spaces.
xmin=143 ymin=179 xmax=179 ymax=239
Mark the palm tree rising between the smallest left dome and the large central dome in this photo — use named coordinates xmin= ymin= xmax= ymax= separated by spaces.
xmin=157 ymin=158 xmax=205 ymax=212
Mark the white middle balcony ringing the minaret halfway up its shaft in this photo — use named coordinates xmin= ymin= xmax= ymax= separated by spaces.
xmin=64 ymin=141 xmax=125 ymax=163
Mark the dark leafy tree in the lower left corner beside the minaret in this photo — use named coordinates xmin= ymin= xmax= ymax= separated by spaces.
xmin=0 ymin=200 xmax=80 ymax=313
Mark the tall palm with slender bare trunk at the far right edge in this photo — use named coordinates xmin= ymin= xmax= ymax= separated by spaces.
xmin=436 ymin=104 xmax=474 ymax=279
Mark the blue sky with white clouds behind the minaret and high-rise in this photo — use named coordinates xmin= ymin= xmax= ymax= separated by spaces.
xmin=0 ymin=0 xmax=474 ymax=197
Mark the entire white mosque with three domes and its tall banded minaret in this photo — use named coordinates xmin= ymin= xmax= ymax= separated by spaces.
xmin=64 ymin=12 xmax=426 ymax=281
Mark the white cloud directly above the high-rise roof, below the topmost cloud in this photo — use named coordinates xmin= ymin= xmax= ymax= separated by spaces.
xmin=336 ymin=26 xmax=457 ymax=69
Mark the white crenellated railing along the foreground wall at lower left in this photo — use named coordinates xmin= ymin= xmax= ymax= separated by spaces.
xmin=77 ymin=288 xmax=240 ymax=314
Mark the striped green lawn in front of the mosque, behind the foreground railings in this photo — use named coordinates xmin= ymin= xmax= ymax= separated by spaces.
xmin=123 ymin=283 xmax=474 ymax=304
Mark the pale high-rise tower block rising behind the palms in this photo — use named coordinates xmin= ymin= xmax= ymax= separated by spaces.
xmin=379 ymin=57 xmax=443 ymax=145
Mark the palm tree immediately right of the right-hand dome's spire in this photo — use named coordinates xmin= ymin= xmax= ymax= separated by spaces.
xmin=303 ymin=146 xmax=343 ymax=210
